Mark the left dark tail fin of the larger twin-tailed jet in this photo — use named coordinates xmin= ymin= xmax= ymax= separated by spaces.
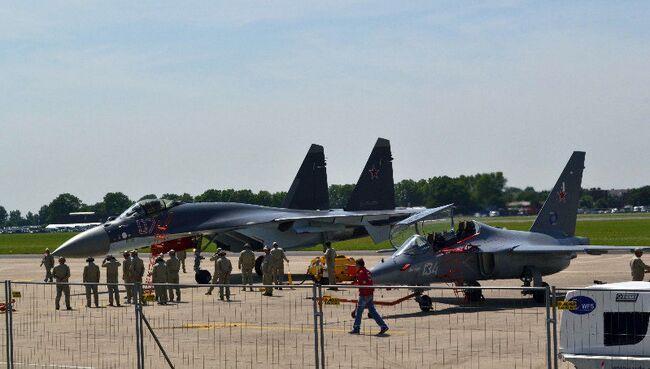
xmin=281 ymin=145 xmax=330 ymax=210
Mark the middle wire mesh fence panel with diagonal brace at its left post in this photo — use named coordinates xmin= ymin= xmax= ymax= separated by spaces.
xmin=144 ymin=285 xmax=315 ymax=368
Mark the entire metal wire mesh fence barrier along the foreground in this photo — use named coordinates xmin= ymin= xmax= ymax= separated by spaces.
xmin=0 ymin=281 xmax=555 ymax=369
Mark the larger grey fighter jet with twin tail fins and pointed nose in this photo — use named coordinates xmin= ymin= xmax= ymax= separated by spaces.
xmin=54 ymin=138 xmax=432 ymax=264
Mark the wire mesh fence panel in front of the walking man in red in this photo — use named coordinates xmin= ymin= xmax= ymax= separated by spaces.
xmin=323 ymin=287 xmax=548 ymax=368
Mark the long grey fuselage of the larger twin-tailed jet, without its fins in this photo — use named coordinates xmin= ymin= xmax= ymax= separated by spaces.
xmin=55 ymin=198 xmax=413 ymax=256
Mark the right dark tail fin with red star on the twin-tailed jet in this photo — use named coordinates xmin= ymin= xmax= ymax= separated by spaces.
xmin=345 ymin=138 xmax=395 ymax=211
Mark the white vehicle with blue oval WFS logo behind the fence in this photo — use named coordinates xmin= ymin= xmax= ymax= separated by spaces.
xmin=558 ymin=282 xmax=650 ymax=369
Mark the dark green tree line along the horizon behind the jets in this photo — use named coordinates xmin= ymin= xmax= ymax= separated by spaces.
xmin=0 ymin=172 xmax=650 ymax=227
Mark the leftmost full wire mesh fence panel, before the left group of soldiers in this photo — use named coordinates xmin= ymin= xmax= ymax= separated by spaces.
xmin=12 ymin=282 xmax=136 ymax=369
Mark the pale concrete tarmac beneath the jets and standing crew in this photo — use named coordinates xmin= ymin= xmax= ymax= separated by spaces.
xmin=0 ymin=252 xmax=632 ymax=368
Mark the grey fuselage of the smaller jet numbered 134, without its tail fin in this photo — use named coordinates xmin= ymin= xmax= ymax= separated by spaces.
xmin=371 ymin=222 xmax=586 ymax=285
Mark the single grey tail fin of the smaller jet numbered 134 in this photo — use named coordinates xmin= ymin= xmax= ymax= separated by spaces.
xmin=530 ymin=151 xmax=585 ymax=238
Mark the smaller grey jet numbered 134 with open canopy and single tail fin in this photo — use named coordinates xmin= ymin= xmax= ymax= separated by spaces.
xmin=371 ymin=151 xmax=638 ymax=311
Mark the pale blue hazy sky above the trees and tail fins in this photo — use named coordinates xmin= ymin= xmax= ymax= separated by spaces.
xmin=0 ymin=1 xmax=650 ymax=213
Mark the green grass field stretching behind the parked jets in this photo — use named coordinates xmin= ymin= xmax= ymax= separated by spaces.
xmin=0 ymin=214 xmax=650 ymax=254
